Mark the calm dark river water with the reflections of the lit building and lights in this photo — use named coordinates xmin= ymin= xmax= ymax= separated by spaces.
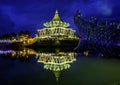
xmin=0 ymin=48 xmax=120 ymax=85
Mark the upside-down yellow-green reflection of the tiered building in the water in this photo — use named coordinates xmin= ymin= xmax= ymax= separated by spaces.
xmin=36 ymin=52 xmax=76 ymax=81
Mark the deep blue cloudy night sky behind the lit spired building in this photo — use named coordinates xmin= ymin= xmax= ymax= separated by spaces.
xmin=0 ymin=0 xmax=120 ymax=35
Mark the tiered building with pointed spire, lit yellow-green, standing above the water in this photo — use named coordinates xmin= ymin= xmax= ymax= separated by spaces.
xmin=37 ymin=10 xmax=76 ymax=40
